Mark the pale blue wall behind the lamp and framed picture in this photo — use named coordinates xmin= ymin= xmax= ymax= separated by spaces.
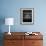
xmin=0 ymin=0 xmax=46 ymax=45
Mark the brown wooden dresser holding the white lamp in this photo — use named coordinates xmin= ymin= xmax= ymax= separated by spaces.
xmin=4 ymin=32 xmax=43 ymax=46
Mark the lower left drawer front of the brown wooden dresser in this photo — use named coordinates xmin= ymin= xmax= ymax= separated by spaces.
xmin=4 ymin=40 xmax=23 ymax=46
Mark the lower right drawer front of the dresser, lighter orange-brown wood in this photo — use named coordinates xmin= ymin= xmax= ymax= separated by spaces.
xmin=24 ymin=40 xmax=43 ymax=46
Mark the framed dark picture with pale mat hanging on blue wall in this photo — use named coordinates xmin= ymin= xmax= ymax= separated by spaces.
xmin=20 ymin=8 xmax=34 ymax=24
